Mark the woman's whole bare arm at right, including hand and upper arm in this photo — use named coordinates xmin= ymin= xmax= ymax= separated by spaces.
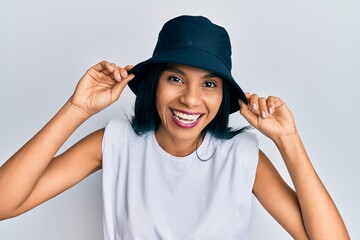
xmin=240 ymin=94 xmax=349 ymax=239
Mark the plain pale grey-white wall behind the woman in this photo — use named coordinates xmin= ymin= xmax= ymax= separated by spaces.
xmin=0 ymin=0 xmax=360 ymax=240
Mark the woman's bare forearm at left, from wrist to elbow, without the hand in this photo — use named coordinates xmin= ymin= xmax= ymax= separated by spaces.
xmin=0 ymin=102 xmax=86 ymax=215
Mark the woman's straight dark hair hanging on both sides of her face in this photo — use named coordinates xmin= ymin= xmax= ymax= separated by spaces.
xmin=131 ymin=64 xmax=249 ymax=139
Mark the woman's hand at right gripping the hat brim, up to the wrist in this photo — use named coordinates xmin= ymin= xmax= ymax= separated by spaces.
xmin=240 ymin=93 xmax=297 ymax=142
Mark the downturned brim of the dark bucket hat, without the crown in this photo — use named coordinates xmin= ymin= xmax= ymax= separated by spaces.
xmin=128 ymin=48 xmax=247 ymax=113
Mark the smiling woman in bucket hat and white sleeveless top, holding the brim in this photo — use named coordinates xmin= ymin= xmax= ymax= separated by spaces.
xmin=0 ymin=16 xmax=349 ymax=239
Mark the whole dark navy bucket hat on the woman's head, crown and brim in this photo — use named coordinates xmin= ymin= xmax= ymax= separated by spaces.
xmin=128 ymin=16 xmax=247 ymax=113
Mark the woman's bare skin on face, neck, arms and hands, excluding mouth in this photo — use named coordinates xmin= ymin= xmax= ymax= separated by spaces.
xmin=0 ymin=61 xmax=350 ymax=239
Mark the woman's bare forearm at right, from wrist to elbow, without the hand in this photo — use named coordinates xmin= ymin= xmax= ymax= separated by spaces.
xmin=275 ymin=134 xmax=349 ymax=239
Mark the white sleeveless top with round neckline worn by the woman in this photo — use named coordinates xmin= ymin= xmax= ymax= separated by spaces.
xmin=103 ymin=119 xmax=259 ymax=240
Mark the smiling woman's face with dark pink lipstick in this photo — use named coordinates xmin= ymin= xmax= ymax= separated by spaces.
xmin=156 ymin=64 xmax=223 ymax=148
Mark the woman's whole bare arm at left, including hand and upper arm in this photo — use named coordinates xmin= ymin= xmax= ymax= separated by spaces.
xmin=0 ymin=62 xmax=133 ymax=219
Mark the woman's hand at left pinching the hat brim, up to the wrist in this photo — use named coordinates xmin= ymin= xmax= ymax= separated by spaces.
xmin=69 ymin=61 xmax=135 ymax=118
